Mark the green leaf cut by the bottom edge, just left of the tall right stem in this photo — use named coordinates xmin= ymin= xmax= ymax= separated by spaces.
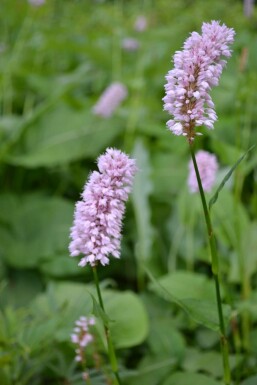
xmin=162 ymin=372 xmax=222 ymax=385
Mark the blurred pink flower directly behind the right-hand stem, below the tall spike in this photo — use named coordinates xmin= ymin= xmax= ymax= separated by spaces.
xmin=188 ymin=150 xmax=218 ymax=193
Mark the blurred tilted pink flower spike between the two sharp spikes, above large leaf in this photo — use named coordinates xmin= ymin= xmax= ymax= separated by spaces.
xmin=93 ymin=82 xmax=128 ymax=118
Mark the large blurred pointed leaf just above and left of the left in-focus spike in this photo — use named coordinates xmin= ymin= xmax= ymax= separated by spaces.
xmin=7 ymin=103 xmax=121 ymax=168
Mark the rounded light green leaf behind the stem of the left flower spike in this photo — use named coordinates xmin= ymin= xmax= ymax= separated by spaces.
xmin=33 ymin=282 xmax=148 ymax=348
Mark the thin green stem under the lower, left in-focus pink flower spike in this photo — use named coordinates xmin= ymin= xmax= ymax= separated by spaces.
xmin=92 ymin=266 xmax=121 ymax=385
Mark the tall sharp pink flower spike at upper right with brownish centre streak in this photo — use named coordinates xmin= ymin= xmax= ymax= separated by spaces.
xmin=163 ymin=21 xmax=235 ymax=142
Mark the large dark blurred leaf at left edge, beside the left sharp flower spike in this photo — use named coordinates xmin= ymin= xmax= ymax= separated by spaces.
xmin=0 ymin=194 xmax=74 ymax=268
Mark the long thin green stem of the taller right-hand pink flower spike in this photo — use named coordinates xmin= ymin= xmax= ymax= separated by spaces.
xmin=189 ymin=142 xmax=231 ymax=385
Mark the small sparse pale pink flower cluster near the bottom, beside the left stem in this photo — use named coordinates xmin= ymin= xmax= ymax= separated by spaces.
xmin=71 ymin=316 xmax=95 ymax=362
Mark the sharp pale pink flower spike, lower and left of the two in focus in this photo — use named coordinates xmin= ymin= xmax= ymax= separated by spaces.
xmin=69 ymin=148 xmax=136 ymax=267
